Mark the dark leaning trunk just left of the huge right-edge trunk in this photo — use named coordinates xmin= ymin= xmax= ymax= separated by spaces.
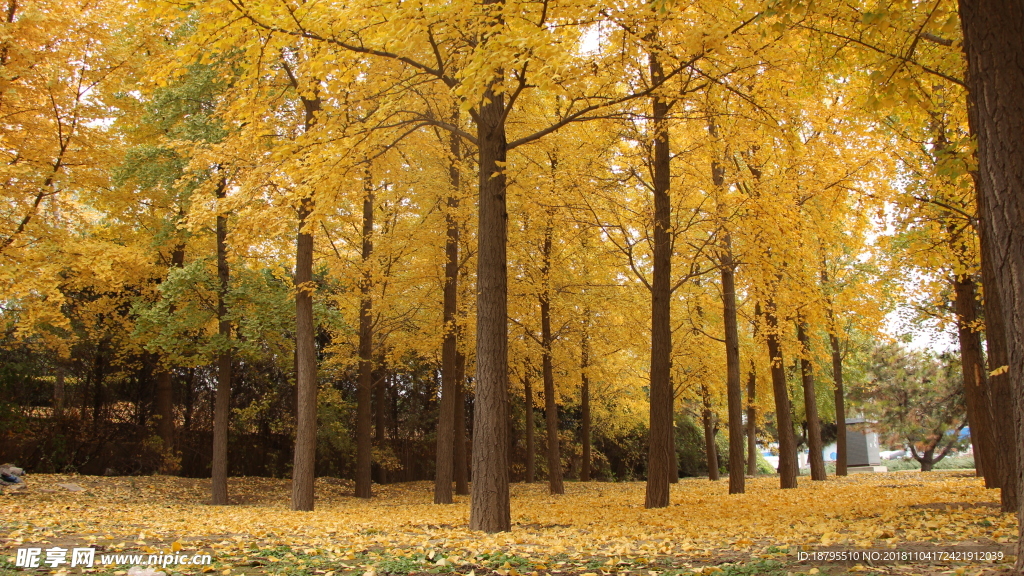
xmin=953 ymin=274 xmax=998 ymax=488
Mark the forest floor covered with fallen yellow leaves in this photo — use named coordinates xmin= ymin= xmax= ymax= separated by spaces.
xmin=0 ymin=470 xmax=1017 ymax=576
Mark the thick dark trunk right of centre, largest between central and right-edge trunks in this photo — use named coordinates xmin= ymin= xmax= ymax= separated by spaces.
xmin=644 ymin=43 xmax=674 ymax=508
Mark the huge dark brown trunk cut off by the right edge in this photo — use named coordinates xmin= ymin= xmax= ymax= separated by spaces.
xmin=959 ymin=0 xmax=1024 ymax=528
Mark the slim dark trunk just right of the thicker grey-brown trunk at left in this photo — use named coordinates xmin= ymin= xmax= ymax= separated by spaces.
xmin=355 ymin=180 xmax=384 ymax=498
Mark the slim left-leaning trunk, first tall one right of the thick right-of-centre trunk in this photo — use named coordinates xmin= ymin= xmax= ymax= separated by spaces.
xmin=721 ymin=234 xmax=744 ymax=494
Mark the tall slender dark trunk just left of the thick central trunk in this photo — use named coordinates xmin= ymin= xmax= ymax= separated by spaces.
xmin=434 ymin=126 xmax=461 ymax=504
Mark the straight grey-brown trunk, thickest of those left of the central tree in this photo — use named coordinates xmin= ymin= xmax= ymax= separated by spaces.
xmin=292 ymin=96 xmax=321 ymax=510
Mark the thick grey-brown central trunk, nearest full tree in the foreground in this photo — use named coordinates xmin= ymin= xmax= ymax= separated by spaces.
xmin=469 ymin=56 xmax=512 ymax=533
